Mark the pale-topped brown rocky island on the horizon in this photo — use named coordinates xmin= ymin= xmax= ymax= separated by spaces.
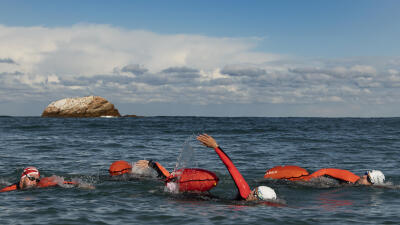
xmin=42 ymin=96 xmax=121 ymax=117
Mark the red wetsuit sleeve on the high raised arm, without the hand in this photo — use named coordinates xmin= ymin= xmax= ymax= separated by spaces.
xmin=214 ymin=147 xmax=251 ymax=199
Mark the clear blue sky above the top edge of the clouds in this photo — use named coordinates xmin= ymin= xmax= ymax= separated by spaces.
xmin=0 ymin=0 xmax=400 ymax=57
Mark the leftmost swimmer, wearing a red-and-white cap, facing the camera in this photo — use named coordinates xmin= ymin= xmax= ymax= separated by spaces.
xmin=0 ymin=166 xmax=86 ymax=192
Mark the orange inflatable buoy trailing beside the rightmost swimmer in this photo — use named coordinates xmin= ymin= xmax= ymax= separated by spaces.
xmin=264 ymin=165 xmax=308 ymax=180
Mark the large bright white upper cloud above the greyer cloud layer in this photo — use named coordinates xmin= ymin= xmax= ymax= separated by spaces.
xmin=0 ymin=24 xmax=277 ymax=76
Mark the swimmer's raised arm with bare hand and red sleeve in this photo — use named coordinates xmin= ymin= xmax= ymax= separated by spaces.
xmin=197 ymin=134 xmax=251 ymax=199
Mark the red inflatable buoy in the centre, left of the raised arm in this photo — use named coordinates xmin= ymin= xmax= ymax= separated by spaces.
xmin=166 ymin=168 xmax=219 ymax=192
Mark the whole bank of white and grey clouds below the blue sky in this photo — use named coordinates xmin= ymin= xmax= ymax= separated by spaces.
xmin=0 ymin=24 xmax=400 ymax=114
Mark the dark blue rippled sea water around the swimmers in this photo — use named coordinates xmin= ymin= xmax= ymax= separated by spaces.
xmin=0 ymin=117 xmax=400 ymax=224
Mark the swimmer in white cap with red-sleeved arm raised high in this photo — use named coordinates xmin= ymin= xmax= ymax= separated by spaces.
xmin=197 ymin=134 xmax=276 ymax=201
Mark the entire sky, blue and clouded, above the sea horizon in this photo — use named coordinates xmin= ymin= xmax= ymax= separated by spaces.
xmin=0 ymin=0 xmax=400 ymax=117
